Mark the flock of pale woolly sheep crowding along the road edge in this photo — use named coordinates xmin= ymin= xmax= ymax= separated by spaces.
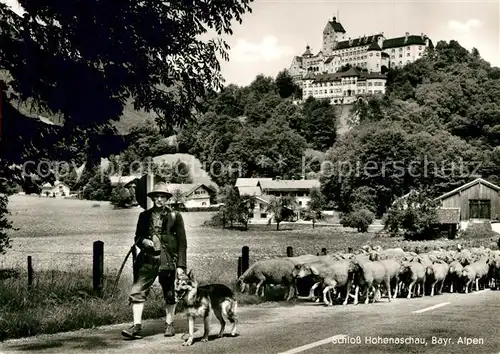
xmin=237 ymin=245 xmax=500 ymax=306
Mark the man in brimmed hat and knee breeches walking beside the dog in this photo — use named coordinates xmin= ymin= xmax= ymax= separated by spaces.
xmin=122 ymin=183 xmax=187 ymax=339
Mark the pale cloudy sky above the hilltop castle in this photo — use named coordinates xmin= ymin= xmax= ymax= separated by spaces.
xmin=0 ymin=0 xmax=500 ymax=86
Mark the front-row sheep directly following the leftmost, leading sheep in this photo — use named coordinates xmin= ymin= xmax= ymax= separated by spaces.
xmin=293 ymin=260 xmax=356 ymax=306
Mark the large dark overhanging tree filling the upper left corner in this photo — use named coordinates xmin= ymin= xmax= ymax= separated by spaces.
xmin=0 ymin=0 xmax=252 ymax=252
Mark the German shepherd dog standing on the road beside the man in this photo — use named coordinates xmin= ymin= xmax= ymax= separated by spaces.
xmin=175 ymin=270 xmax=238 ymax=346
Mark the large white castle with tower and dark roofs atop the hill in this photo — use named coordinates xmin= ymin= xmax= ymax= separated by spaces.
xmin=288 ymin=17 xmax=432 ymax=104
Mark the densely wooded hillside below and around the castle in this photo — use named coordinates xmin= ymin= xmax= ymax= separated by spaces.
xmin=178 ymin=41 xmax=500 ymax=216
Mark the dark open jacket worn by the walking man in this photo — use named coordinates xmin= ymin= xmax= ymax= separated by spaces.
xmin=135 ymin=208 xmax=187 ymax=270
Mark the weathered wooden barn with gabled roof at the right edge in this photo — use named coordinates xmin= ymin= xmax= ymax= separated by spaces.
xmin=436 ymin=178 xmax=500 ymax=221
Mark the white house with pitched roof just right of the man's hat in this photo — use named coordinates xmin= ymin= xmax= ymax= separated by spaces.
xmin=167 ymin=183 xmax=217 ymax=209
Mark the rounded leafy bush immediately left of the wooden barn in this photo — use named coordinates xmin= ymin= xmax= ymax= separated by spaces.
xmin=384 ymin=191 xmax=439 ymax=241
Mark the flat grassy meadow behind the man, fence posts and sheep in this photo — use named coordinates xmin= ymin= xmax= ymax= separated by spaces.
xmin=0 ymin=195 xmax=498 ymax=340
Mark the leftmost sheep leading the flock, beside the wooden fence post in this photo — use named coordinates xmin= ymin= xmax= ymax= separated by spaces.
xmin=237 ymin=258 xmax=295 ymax=301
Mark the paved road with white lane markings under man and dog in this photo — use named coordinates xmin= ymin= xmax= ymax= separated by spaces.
xmin=0 ymin=290 xmax=500 ymax=354
